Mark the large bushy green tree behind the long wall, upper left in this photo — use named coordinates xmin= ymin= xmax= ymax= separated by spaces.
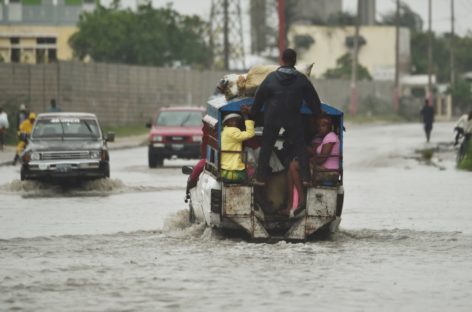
xmin=69 ymin=1 xmax=211 ymax=66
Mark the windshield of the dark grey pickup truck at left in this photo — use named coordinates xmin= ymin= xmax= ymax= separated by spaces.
xmin=32 ymin=117 xmax=100 ymax=138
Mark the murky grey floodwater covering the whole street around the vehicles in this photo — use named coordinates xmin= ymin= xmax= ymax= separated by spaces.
xmin=0 ymin=123 xmax=472 ymax=312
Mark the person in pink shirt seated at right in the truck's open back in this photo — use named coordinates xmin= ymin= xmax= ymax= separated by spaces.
xmin=280 ymin=117 xmax=339 ymax=217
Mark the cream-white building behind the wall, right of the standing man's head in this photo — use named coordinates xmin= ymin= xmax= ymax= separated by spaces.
xmin=288 ymin=25 xmax=410 ymax=80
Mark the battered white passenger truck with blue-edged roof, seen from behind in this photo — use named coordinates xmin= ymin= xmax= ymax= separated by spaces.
xmin=182 ymin=97 xmax=344 ymax=241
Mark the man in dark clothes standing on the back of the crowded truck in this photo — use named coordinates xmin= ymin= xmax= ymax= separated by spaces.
xmin=251 ymin=49 xmax=321 ymax=186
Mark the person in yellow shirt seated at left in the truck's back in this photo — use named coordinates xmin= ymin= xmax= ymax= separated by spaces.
xmin=220 ymin=107 xmax=255 ymax=183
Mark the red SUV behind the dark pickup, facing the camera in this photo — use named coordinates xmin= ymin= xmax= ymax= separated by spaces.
xmin=147 ymin=106 xmax=205 ymax=168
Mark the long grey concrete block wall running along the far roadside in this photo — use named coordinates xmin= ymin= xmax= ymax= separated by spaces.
xmin=0 ymin=62 xmax=393 ymax=125
